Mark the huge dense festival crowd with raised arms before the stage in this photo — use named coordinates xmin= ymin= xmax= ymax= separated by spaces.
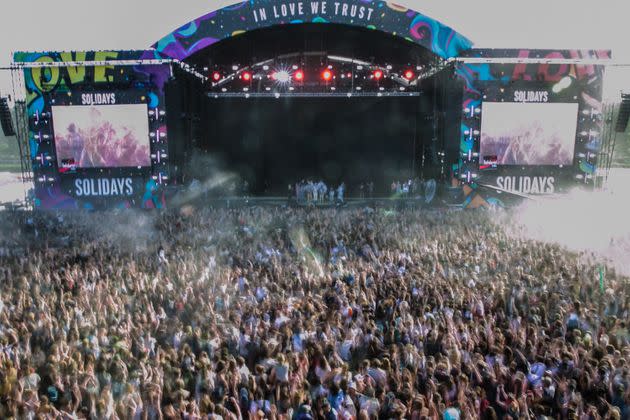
xmin=0 ymin=207 xmax=630 ymax=420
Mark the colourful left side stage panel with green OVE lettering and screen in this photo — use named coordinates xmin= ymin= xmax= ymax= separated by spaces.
xmin=14 ymin=51 xmax=171 ymax=209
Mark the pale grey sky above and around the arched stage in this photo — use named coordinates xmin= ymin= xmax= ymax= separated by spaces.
xmin=0 ymin=0 xmax=630 ymax=97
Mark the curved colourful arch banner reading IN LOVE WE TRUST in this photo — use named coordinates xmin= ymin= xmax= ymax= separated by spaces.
xmin=153 ymin=0 xmax=472 ymax=60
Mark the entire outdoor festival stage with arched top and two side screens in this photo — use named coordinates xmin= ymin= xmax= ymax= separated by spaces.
xmin=7 ymin=0 xmax=611 ymax=209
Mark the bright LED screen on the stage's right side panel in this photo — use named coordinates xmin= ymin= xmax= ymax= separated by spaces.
xmin=479 ymin=102 xmax=578 ymax=166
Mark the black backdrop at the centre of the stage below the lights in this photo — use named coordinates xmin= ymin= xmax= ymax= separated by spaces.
xmin=195 ymin=97 xmax=433 ymax=195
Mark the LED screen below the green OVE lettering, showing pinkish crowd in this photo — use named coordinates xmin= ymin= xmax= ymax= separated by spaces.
xmin=52 ymin=104 xmax=151 ymax=172
